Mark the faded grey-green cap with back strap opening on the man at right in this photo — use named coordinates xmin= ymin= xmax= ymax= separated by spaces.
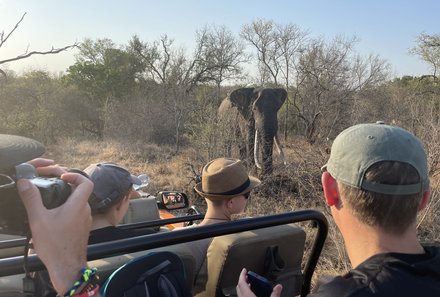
xmin=322 ymin=122 xmax=429 ymax=195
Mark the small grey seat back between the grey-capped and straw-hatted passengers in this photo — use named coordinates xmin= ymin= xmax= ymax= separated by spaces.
xmin=121 ymin=197 xmax=160 ymax=224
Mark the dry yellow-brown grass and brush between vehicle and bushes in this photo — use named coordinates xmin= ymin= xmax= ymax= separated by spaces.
xmin=46 ymin=139 xmax=440 ymax=281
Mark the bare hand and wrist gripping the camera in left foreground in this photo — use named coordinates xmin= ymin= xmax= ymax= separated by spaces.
xmin=17 ymin=173 xmax=93 ymax=295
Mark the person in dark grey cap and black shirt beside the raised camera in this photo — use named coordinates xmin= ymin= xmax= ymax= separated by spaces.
xmin=84 ymin=162 xmax=155 ymax=244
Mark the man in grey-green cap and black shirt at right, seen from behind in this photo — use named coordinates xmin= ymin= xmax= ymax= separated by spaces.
xmin=237 ymin=122 xmax=440 ymax=297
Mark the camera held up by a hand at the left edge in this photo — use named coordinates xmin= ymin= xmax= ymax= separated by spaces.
xmin=0 ymin=163 xmax=71 ymax=235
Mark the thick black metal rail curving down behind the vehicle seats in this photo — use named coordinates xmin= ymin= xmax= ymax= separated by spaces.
xmin=0 ymin=210 xmax=328 ymax=297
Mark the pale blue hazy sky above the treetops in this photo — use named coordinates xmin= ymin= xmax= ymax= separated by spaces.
xmin=0 ymin=0 xmax=440 ymax=77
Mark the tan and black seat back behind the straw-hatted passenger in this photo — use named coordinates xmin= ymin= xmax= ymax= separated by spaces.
xmin=193 ymin=224 xmax=306 ymax=297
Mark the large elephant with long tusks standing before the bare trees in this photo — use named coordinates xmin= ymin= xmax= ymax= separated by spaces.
xmin=219 ymin=88 xmax=287 ymax=176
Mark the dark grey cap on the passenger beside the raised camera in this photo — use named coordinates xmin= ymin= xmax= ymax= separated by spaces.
xmin=84 ymin=163 xmax=142 ymax=209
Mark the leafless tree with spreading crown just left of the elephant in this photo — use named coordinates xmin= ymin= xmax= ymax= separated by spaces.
xmin=129 ymin=31 xmax=248 ymax=151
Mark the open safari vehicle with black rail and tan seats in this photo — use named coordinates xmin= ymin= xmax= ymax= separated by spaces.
xmin=0 ymin=194 xmax=328 ymax=297
